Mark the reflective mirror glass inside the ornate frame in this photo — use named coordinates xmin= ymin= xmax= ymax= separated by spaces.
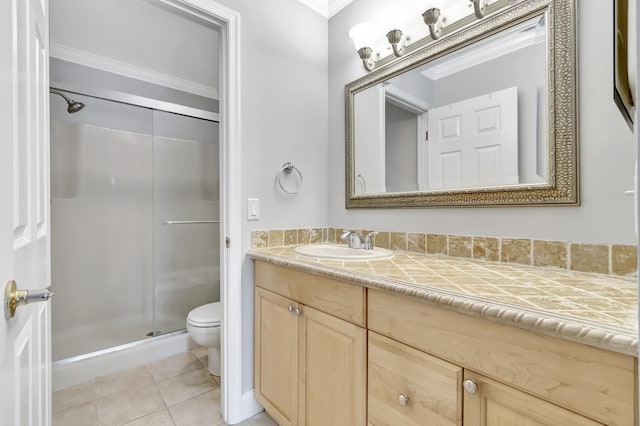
xmin=353 ymin=15 xmax=549 ymax=195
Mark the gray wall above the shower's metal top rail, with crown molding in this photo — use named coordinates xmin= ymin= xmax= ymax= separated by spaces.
xmin=50 ymin=0 xmax=219 ymax=89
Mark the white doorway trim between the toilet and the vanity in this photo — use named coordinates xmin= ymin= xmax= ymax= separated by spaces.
xmin=151 ymin=0 xmax=249 ymax=424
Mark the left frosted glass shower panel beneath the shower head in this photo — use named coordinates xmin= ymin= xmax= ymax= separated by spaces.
xmin=51 ymin=94 xmax=153 ymax=361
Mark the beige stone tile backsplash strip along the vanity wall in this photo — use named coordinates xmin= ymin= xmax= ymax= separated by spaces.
xmin=251 ymin=228 xmax=638 ymax=276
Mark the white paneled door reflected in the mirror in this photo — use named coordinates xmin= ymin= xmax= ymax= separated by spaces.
xmin=427 ymin=87 xmax=519 ymax=189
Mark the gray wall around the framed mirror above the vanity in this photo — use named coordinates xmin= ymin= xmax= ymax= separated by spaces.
xmin=329 ymin=0 xmax=635 ymax=244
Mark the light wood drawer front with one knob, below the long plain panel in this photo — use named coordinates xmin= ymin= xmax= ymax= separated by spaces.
xmin=367 ymin=331 xmax=462 ymax=426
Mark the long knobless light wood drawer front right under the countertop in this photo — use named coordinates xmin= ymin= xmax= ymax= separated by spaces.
xmin=367 ymin=290 xmax=637 ymax=426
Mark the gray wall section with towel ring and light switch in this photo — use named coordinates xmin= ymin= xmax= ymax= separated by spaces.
xmin=212 ymin=0 xmax=328 ymax=390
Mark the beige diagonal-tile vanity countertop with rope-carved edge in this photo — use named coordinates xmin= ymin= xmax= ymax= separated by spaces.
xmin=248 ymin=246 xmax=638 ymax=356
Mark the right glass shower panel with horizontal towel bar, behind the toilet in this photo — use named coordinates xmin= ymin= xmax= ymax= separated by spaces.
xmin=153 ymin=111 xmax=220 ymax=334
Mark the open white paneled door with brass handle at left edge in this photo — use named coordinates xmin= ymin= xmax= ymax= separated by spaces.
xmin=0 ymin=0 xmax=51 ymax=426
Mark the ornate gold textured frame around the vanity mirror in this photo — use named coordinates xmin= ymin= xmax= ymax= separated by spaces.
xmin=345 ymin=0 xmax=579 ymax=208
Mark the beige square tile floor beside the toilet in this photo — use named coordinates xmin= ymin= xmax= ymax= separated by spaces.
xmin=53 ymin=348 xmax=276 ymax=426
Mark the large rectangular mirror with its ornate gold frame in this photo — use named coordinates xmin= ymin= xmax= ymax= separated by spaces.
xmin=346 ymin=0 xmax=578 ymax=208
